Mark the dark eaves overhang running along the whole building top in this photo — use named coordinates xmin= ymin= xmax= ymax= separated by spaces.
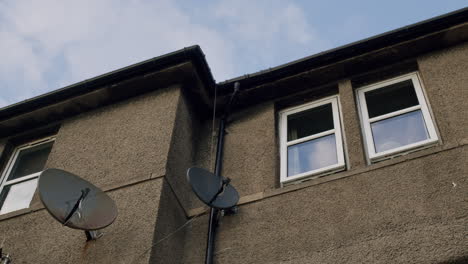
xmin=0 ymin=8 xmax=468 ymax=138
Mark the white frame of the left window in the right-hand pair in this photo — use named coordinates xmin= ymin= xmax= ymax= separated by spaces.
xmin=279 ymin=95 xmax=346 ymax=186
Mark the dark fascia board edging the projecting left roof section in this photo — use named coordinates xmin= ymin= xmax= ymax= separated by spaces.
xmin=0 ymin=45 xmax=216 ymax=120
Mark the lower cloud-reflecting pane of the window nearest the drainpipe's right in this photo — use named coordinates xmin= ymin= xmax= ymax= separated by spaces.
xmin=288 ymin=134 xmax=338 ymax=176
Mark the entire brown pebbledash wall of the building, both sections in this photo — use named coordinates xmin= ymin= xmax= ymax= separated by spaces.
xmin=0 ymin=29 xmax=468 ymax=264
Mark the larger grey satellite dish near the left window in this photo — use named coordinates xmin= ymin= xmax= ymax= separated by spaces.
xmin=39 ymin=169 xmax=117 ymax=232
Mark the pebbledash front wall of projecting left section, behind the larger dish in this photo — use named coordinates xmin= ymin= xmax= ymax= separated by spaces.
xmin=0 ymin=85 xmax=191 ymax=264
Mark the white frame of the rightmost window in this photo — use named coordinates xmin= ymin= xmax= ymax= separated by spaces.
xmin=356 ymin=72 xmax=439 ymax=163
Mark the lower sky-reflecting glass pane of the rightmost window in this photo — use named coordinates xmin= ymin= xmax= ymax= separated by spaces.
xmin=371 ymin=110 xmax=429 ymax=153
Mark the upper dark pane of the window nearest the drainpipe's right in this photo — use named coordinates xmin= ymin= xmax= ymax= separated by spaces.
xmin=288 ymin=104 xmax=334 ymax=141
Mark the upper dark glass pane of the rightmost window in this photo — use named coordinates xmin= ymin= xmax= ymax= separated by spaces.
xmin=365 ymin=80 xmax=419 ymax=118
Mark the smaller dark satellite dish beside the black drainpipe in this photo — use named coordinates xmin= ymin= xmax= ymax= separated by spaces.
xmin=187 ymin=167 xmax=239 ymax=209
